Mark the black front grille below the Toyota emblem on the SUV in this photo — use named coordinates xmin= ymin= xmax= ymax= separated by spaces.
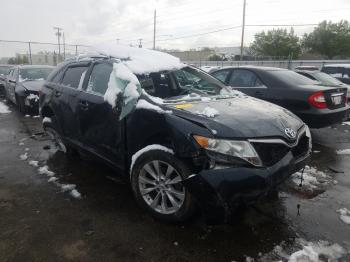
xmin=252 ymin=133 xmax=309 ymax=166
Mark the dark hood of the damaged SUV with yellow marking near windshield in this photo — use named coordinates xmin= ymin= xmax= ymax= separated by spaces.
xmin=165 ymin=96 xmax=304 ymax=140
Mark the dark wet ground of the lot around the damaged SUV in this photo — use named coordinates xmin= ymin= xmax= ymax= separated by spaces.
xmin=0 ymin=101 xmax=350 ymax=261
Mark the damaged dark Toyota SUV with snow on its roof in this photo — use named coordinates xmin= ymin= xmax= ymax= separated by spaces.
xmin=40 ymin=45 xmax=311 ymax=221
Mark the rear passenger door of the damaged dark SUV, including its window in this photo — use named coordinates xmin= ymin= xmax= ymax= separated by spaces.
xmin=54 ymin=63 xmax=90 ymax=144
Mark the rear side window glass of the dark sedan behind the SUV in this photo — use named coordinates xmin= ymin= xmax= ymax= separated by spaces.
xmin=229 ymin=69 xmax=263 ymax=87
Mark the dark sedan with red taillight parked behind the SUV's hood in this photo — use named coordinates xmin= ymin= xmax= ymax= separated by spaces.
xmin=211 ymin=66 xmax=349 ymax=128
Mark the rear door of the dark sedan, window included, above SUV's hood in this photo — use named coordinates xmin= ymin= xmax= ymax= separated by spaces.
xmin=227 ymin=69 xmax=269 ymax=100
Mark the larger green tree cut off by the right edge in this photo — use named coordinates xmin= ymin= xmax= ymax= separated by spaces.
xmin=302 ymin=20 xmax=350 ymax=59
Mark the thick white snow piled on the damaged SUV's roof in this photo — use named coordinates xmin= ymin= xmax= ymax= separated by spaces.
xmin=91 ymin=43 xmax=185 ymax=74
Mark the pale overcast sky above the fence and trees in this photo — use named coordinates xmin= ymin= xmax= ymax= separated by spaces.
xmin=0 ymin=0 xmax=350 ymax=56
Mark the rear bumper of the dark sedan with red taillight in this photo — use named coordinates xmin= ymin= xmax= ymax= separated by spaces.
xmin=297 ymin=109 xmax=349 ymax=128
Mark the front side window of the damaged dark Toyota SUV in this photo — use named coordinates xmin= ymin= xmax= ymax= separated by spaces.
xmin=86 ymin=63 xmax=113 ymax=95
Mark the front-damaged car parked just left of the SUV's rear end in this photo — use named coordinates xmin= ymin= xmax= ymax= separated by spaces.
xmin=5 ymin=65 xmax=54 ymax=113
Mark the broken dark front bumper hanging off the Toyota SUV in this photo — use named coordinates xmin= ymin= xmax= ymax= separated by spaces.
xmin=184 ymin=152 xmax=310 ymax=221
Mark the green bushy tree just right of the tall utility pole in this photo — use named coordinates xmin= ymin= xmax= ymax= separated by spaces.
xmin=250 ymin=28 xmax=301 ymax=58
